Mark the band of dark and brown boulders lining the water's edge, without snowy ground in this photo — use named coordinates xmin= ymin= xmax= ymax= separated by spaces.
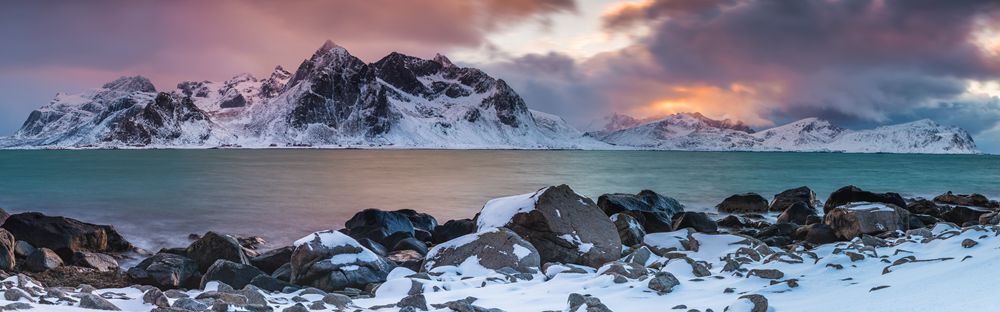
xmin=0 ymin=185 xmax=1000 ymax=311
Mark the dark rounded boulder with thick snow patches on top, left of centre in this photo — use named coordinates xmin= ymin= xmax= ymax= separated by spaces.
xmin=290 ymin=229 xmax=394 ymax=291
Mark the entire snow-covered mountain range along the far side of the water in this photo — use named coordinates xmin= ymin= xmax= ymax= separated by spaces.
xmin=0 ymin=41 xmax=978 ymax=153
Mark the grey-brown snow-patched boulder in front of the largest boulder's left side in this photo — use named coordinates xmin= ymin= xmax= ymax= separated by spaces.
xmin=423 ymin=228 xmax=541 ymax=273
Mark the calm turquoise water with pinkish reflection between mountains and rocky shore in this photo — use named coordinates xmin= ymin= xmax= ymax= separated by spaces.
xmin=0 ymin=150 xmax=1000 ymax=248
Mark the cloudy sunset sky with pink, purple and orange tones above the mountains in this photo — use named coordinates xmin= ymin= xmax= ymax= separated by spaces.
xmin=0 ymin=0 xmax=1000 ymax=153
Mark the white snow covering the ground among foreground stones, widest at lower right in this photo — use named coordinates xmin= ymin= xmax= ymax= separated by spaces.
xmin=0 ymin=224 xmax=1000 ymax=312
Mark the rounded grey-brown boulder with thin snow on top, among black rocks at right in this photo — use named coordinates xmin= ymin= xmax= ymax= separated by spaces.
xmin=824 ymin=202 xmax=909 ymax=240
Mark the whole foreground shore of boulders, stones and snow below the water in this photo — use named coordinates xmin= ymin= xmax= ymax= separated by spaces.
xmin=0 ymin=185 xmax=1000 ymax=312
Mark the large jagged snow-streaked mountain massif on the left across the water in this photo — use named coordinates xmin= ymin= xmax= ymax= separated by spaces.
xmin=0 ymin=41 xmax=609 ymax=149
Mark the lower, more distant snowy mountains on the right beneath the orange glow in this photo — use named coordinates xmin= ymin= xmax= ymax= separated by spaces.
xmin=588 ymin=113 xmax=979 ymax=154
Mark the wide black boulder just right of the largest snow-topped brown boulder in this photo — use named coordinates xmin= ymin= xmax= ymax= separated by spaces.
xmin=597 ymin=190 xmax=684 ymax=233
